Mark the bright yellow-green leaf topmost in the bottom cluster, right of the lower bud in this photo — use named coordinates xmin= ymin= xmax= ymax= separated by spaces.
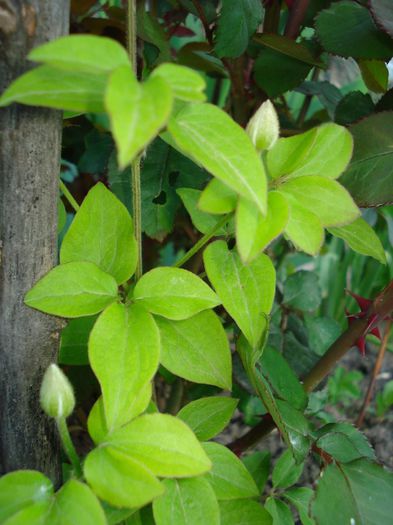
xmin=106 ymin=414 xmax=211 ymax=477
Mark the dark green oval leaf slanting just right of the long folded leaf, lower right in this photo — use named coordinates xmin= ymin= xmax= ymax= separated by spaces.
xmin=260 ymin=346 xmax=308 ymax=410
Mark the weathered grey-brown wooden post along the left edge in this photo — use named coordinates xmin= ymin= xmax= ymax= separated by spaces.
xmin=0 ymin=0 xmax=69 ymax=484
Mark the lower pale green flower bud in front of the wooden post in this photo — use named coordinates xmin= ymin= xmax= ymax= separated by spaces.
xmin=40 ymin=364 xmax=75 ymax=418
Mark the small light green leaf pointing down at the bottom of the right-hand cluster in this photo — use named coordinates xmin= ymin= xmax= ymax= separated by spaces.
xmin=284 ymin=195 xmax=325 ymax=255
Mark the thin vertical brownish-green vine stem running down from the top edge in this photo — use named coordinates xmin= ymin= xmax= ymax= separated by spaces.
xmin=127 ymin=0 xmax=143 ymax=280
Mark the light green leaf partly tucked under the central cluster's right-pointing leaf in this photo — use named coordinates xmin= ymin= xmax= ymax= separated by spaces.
xmin=156 ymin=310 xmax=232 ymax=390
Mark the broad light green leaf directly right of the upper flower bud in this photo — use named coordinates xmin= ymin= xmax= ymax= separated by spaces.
xmin=266 ymin=122 xmax=353 ymax=180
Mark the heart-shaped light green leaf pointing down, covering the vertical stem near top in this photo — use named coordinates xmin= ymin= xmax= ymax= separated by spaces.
xmin=105 ymin=66 xmax=172 ymax=168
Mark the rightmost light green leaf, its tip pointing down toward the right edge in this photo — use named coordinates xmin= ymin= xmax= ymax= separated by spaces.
xmin=329 ymin=217 xmax=386 ymax=264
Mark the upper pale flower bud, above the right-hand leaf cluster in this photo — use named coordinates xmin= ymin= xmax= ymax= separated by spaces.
xmin=246 ymin=100 xmax=280 ymax=151
